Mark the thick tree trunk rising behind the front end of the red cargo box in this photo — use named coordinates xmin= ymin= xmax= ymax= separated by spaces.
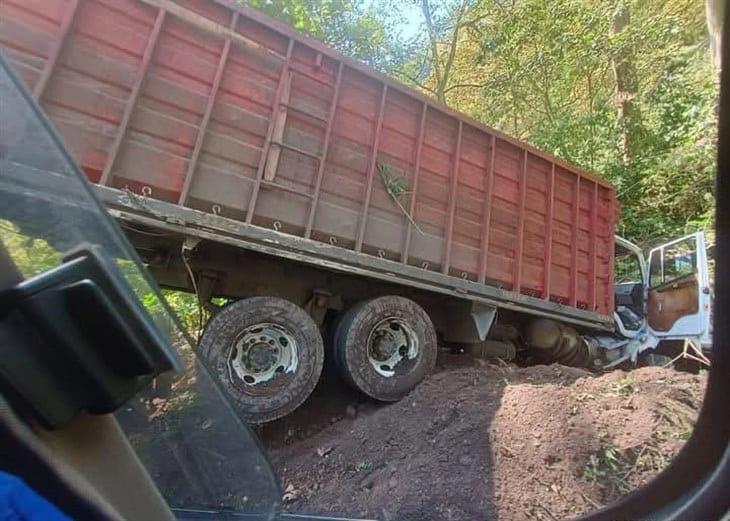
xmin=612 ymin=0 xmax=641 ymax=164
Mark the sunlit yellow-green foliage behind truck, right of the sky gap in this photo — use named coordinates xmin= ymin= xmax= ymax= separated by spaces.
xmin=384 ymin=0 xmax=718 ymax=247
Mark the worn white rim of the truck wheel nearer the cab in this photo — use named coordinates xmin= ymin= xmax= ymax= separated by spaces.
xmin=368 ymin=317 xmax=419 ymax=378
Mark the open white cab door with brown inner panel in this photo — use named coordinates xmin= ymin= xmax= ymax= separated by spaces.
xmin=647 ymin=232 xmax=711 ymax=347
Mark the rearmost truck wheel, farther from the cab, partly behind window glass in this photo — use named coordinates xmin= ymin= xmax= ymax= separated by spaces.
xmin=200 ymin=297 xmax=324 ymax=423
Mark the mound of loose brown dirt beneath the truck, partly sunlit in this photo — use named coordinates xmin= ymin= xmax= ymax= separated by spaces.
xmin=270 ymin=365 xmax=705 ymax=520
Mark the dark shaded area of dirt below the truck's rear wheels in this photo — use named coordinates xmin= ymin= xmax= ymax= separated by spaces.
xmin=261 ymin=354 xmax=506 ymax=520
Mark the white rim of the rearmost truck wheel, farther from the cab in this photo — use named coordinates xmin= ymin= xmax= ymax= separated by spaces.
xmin=228 ymin=323 xmax=299 ymax=395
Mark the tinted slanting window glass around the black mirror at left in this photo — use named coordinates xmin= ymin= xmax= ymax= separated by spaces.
xmin=0 ymin=55 xmax=281 ymax=518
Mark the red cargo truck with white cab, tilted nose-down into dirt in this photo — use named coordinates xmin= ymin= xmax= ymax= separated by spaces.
xmin=0 ymin=0 xmax=709 ymax=422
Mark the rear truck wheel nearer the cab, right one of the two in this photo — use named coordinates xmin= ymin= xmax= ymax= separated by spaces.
xmin=334 ymin=296 xmax=437 ymax=402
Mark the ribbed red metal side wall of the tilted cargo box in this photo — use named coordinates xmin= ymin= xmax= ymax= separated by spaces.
xmin=0 ymin=0 xmax=617 ymax=315
